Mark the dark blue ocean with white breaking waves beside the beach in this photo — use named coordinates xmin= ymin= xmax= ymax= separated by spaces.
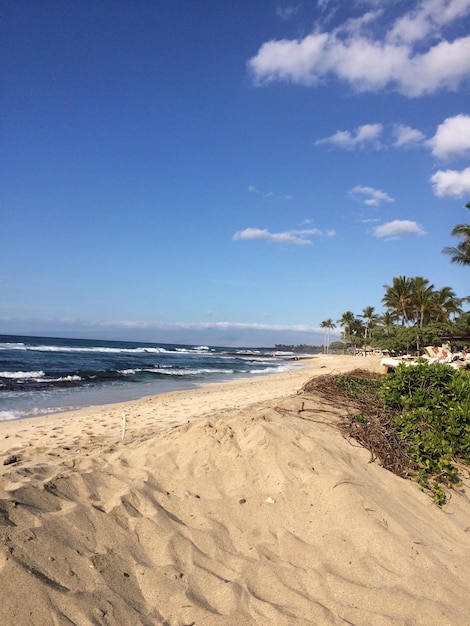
xmin=0 ymin=335 xmax=299 ymax=421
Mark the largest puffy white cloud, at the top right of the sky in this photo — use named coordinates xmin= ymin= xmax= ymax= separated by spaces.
xmin=247 ymin=0 xmax=470 ymax=97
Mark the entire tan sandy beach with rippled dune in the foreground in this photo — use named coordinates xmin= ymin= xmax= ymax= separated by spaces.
xmin=0 ymin=355 xmax=470 ymax=626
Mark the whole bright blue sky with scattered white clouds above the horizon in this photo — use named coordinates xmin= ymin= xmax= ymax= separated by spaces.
xmin=0 ymin=0 xmax=470 ymax=346
